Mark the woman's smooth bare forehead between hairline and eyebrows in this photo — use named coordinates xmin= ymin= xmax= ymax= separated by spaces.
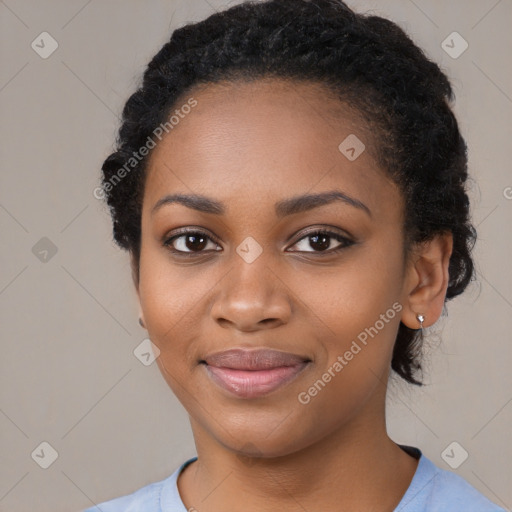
xmin=144 ymin=79 xmax=396 ymax=219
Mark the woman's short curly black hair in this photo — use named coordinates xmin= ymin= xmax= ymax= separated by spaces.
xmin=101 ymin=0 xmax=476 ymax=386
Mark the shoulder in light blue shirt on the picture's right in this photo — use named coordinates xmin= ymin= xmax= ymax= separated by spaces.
xmin=395 ymin=446 xmax=506 ymax=512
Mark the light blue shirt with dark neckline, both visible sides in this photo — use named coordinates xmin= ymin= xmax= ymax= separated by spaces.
xmin=84 ymin=445 xmax=506 ymax=512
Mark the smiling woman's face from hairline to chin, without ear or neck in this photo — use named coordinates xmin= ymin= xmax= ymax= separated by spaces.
xmin=138 ymin=80 xmax=407 ymax=456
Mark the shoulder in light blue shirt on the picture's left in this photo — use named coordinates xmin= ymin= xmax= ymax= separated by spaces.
xmin=83 ymin=457 xmax=197 ymax=512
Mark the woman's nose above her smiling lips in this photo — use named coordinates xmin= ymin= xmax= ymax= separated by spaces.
xmin=211 ymin=258 xmax=292 ymax=332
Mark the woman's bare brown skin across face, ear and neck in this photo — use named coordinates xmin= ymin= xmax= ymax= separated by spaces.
xmin=132 ymin=79 xmax=452 ymax=512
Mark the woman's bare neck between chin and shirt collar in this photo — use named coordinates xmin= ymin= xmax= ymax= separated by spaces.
xmin=178 ymin=388 xmax=418 ymax=512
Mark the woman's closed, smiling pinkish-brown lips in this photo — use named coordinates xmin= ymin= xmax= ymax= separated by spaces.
xmin=201 ymin=349 xmax=311 ymax=398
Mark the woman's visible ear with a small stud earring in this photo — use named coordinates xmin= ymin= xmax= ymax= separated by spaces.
xmin=402 ymin=233 xmax=453 ymax=329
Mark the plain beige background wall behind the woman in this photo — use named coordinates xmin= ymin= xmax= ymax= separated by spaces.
xmin=0 ymin=0 xmax=512 ymax=512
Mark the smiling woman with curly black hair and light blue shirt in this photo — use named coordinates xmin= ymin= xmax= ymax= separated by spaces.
xmin=84 ymin=0 xmax=503 ymax=512
